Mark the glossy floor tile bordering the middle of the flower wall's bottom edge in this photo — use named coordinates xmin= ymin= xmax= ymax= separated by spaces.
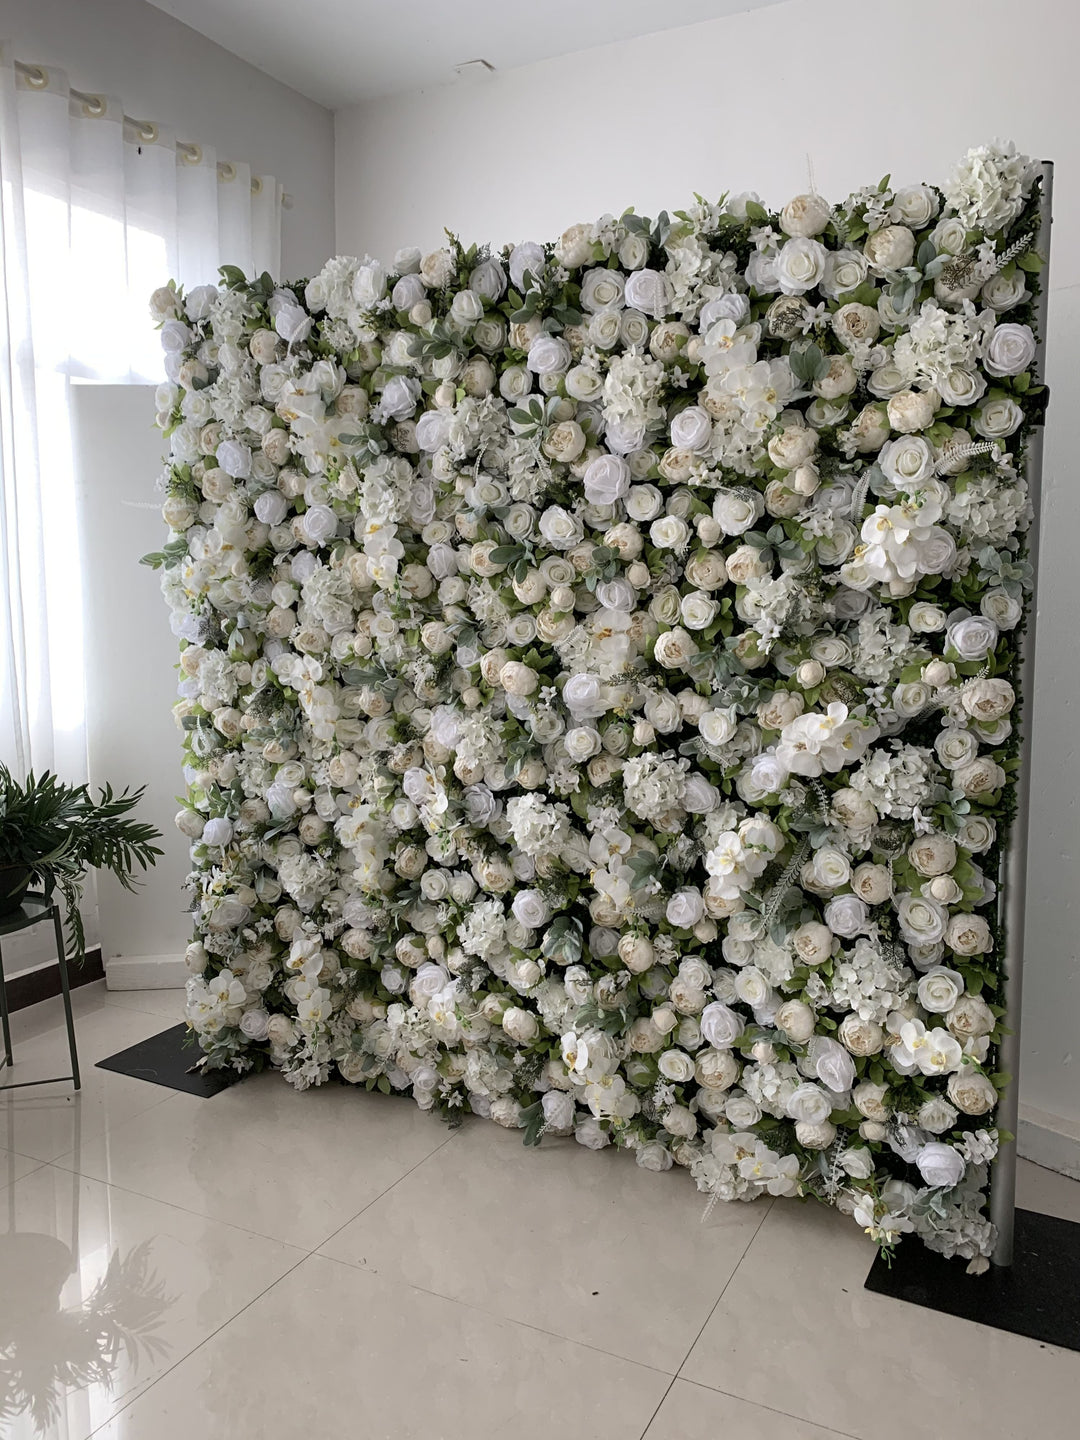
xmin=321 ymin=1120 xmax=768 ymax=1375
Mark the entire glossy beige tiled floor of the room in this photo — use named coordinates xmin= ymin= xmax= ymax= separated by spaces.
xmin=0 ymin=984 xmax=1080 ymax=1440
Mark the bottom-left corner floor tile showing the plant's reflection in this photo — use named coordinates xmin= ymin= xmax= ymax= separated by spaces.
xmin=0 ymin=1165 xmax=304 ymax=1440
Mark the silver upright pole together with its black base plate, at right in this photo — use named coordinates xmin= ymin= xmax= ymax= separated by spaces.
xmin=865 ymin=160 xmax=1080 ymax=1351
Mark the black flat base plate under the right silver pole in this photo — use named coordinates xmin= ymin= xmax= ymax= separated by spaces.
xmin=865 ymin=1210 xmax=1080 ymax=1351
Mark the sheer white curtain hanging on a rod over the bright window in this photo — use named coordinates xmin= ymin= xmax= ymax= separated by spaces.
xmin=0 ymin=43 xmax=282 ymax=780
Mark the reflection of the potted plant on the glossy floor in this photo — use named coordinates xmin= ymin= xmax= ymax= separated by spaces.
xmin=0 ymin=1225 xmax=174 ymax=1436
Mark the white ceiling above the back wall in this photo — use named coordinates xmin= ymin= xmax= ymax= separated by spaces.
xmin=151 ymin=0 xmax=780 ymax=108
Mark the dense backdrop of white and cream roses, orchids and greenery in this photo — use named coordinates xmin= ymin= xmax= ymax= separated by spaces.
xmin=148 ymin=147 xmax=1044 ymax=1266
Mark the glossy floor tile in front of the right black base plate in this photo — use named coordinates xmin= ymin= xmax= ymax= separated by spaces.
xmin=681 ymin=1201 xmax=1080 ymax=1440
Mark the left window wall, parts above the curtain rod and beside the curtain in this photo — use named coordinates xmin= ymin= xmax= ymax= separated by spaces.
xmin=0 ymin=0 xmax=334 ymax=984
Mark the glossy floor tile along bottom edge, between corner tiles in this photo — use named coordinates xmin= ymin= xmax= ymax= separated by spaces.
xmin=95 ymin=1256 xmax=668 ymax=1440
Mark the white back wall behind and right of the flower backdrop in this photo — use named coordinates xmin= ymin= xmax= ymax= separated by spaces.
xmin=336 ymin=0 xmax=1080 ymax=1153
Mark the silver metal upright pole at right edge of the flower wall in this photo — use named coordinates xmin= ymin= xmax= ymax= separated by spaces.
xmin=991 ymin=160 xmax=1054 ymax=1266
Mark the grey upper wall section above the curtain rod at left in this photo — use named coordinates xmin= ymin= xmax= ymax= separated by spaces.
xmin=8 ymin=0 xmax=334 ymax=279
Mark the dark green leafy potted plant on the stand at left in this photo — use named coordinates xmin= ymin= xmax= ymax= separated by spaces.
xmin=0 ymin=765 xmax=161 ymax=959
